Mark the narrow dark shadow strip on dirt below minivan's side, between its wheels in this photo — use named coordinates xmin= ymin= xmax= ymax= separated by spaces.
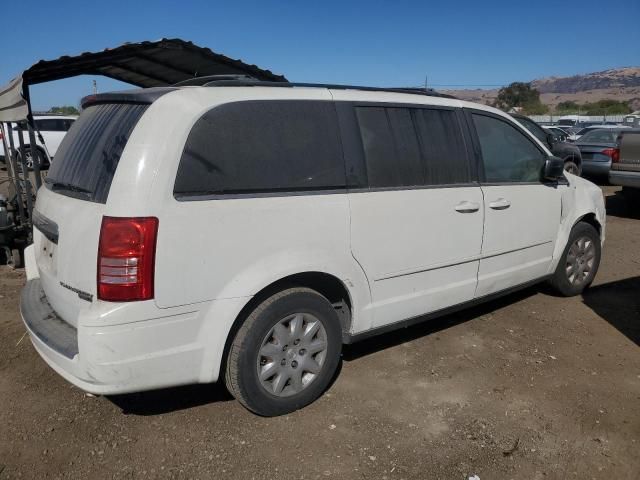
xmin=342 ymin=285 xmax=546 ymax=362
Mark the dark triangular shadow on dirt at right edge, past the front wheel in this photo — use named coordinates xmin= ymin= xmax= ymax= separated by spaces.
xmin=582 ymin=276 xmax=640 ymax=346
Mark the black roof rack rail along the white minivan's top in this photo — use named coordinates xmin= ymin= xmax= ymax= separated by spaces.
xmin=192 ymin=79 xmax=456 ymax=99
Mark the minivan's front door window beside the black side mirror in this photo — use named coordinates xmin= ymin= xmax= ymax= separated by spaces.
xmin=473 ymin=114 xmax=545 ymax=182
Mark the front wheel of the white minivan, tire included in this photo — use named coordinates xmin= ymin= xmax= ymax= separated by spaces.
xmin=549 ymin=222 xmax=601 ymax=297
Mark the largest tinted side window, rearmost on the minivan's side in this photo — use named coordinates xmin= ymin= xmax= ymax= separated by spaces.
xmin=174 ymin=101 xmax=346 ymax=195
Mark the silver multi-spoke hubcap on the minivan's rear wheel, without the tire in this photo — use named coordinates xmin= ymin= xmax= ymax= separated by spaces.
xmin=257 ymin=313 xmax=327 ymax=397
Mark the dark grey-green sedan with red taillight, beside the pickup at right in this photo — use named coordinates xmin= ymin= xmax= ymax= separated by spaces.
xmin=575 ymin=128 xmax=625 ymax=177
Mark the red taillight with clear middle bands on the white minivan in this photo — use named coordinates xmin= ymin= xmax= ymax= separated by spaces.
xmin=98 ymin=217 xmax=158 ymax=302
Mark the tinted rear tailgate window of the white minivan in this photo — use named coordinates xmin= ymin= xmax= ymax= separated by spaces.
xmin=45 ymin=104 xmax=148 ymax=203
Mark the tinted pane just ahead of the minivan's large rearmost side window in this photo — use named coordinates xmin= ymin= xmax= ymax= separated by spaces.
xmin=356 ymin=107 xmax=424 ymax=187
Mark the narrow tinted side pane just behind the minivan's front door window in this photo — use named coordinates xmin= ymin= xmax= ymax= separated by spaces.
xmin=413 ymin=109 xmax=471 ymax=185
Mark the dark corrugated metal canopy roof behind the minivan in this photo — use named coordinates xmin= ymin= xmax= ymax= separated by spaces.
xmin=0 ymin=38 xmax=287 ymax=121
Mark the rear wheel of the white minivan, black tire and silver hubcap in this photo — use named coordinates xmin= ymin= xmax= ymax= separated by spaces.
xmin=225 ymin=287 xmax=342 ymax=417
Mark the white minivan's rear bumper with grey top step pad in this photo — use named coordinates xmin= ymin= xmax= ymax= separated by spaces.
xmin=20 ymin=278 xmax=218 ymax=395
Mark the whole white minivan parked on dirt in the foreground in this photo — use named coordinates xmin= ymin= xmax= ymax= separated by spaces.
xmin=21 ymin=81 xmax=605 ymax=415
